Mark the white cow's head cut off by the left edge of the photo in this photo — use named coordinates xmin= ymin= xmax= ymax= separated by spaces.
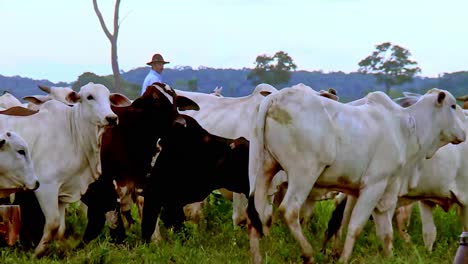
xmin=0 ymin=131 xmax=39 ymax=194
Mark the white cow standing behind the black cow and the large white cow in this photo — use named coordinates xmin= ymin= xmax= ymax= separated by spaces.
xmin=176 ymin=83 xmax=338 ymax=225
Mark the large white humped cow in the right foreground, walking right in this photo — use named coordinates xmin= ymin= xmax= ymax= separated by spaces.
xmin=248 ymin=88 xmax=466 ymax=263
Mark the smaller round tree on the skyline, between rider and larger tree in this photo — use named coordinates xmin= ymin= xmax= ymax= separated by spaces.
xmin=247 ymin=51 xmax=297 ymax=85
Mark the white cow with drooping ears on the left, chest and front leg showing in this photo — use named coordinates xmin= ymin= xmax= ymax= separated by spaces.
xmin=0 ymin=83 xmax=128 ymax=257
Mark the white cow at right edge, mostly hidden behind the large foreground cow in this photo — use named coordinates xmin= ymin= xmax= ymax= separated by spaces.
xmin=376 ymin=94 xmax=468 ymax=251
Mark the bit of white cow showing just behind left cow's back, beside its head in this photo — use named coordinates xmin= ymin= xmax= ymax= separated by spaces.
xmin=23 ymin=85 xmax=73 ymax=110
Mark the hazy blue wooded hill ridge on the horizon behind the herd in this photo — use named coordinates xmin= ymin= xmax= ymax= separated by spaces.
xmin=0 ymin=67 xmax=468 ymax=102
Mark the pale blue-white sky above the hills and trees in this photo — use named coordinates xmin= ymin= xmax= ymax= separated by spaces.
xmin=0 ymin=0 xmax=468 ymax=82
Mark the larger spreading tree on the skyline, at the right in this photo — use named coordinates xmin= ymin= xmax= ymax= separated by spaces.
xmin=359 ymin=42 xmax=421 ymax=94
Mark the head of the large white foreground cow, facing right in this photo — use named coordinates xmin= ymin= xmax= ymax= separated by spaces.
xmin=410 ymin=88 xmax=466 ymax=158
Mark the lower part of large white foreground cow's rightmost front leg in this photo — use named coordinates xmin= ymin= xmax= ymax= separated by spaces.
xmin=372 ymin=208 xmax=394 ymax=256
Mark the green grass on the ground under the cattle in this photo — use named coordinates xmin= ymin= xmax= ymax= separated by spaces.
xmin=0 ymin=196 xmax=461 ymax=264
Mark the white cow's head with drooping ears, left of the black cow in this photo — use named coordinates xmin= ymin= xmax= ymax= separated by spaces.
xmin=66 ymin=82 xmax=130 ymax=126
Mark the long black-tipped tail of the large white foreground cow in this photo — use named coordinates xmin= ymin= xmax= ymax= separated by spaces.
xmin=247 ymin=91 xmax=272 ymax=234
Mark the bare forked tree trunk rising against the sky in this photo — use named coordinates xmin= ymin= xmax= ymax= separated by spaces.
xmin=93 ymin=0 xmax=122 ymax=93
